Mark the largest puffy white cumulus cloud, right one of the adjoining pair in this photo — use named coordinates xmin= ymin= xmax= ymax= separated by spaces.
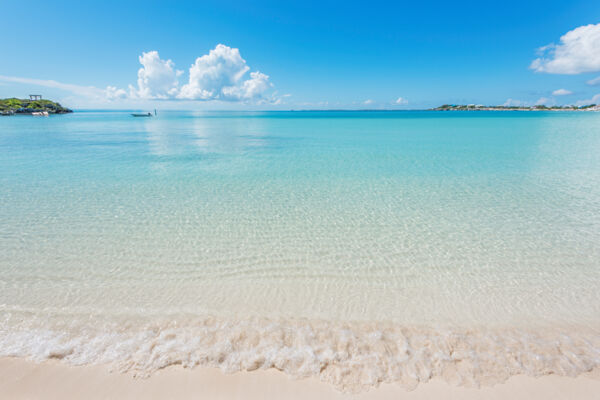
xmin=177 ymin=44 xmax=273 ymax=101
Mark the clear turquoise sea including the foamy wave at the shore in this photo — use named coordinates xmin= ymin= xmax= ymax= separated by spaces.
xmin=0 ymin=111 xmax=600 ymax=390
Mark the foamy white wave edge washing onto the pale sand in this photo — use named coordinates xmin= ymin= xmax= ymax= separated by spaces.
xmin=0 ymin=318 xmax=600 ymax=392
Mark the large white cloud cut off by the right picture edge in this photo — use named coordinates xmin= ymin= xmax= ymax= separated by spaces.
xmin=530 ymin=24 xmax=600 ymax=75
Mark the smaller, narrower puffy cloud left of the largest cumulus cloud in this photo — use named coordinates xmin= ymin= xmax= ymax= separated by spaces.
xmin=129 ymin=51 xmax=183 ymax=99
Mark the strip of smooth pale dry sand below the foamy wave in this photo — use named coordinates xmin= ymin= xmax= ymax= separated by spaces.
xmin=0 ymin=358 xmax=600 ymax=400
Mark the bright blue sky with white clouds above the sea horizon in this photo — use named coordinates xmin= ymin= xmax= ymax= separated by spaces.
xmin=0 ymin=0 xmax=600 ymax=110
